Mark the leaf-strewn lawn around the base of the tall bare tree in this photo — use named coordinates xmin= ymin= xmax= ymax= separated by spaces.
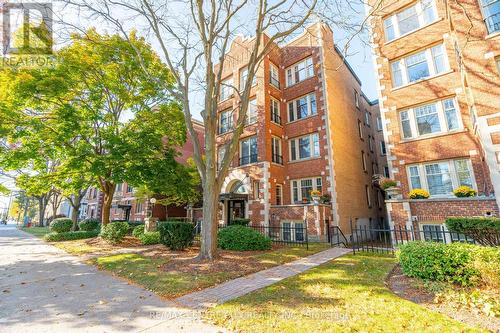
xmin=92 ymin=241 xmax=332 ymax=298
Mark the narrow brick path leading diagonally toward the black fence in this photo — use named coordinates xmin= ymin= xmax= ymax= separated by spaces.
xmin=175 ymin=248 xmax=351 ymax=309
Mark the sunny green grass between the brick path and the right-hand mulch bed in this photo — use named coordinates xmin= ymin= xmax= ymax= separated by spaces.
xmin=206 ymin=254 xmax=480 ymax=333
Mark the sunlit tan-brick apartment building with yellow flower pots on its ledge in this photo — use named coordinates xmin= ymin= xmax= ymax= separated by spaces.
xmin=370 ymin=0 xmax=500 ymax=230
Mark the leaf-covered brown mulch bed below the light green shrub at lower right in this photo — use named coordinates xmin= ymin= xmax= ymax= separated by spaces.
xmin=386 ymin=265 xmax=500 ymax=332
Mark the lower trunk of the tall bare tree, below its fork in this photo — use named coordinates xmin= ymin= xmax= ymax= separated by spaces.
xmin=198 ymin=170 xmax=219 ymax=260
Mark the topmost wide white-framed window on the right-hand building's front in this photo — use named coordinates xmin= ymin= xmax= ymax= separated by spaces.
xmin=384 ymin=0 xmax=438 ymax=42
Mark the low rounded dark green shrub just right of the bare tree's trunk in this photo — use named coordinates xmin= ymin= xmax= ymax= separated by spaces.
xmin=217 ymin=225 xmax=272 ymax=251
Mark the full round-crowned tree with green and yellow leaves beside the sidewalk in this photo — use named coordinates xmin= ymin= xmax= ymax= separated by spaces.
xmin=2 ymin=30 xmax=186 ymax=224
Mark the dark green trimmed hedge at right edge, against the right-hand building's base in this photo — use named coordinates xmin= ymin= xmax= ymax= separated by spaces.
xmin=446 ymin=217 xmax=500 ymax=246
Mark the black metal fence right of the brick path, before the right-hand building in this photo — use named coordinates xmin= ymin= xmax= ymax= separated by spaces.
xmin=349 ymin=225 xmax=500 ymax=253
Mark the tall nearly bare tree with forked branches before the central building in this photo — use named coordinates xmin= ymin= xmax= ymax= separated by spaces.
xmin=59 ymin=0 xmax=372 ymax=259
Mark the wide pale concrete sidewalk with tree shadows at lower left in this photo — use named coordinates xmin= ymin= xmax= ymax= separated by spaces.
xmin=0 ymin=225 xmax=225 ymax=333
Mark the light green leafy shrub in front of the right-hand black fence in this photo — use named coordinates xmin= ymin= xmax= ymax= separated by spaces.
xmin=398 ymin=241 xmax=480 ymax=286
